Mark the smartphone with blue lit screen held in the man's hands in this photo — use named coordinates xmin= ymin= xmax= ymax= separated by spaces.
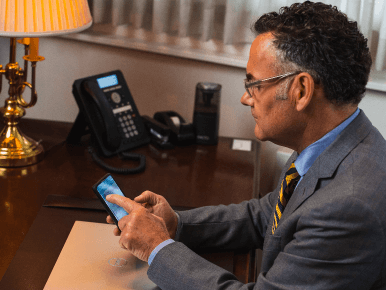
xmin=92 ymin=173 xmax=128 ymax=229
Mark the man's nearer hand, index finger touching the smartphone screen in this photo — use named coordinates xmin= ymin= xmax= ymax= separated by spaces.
xmin=106 ymin=194 xmax=170 ymax=262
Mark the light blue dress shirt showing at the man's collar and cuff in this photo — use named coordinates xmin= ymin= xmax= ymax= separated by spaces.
xmin=148 ymin=108 xmax=360 ymax=266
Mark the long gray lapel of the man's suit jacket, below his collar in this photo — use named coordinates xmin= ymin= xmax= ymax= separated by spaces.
xmin=279 ymin=111 xmax=373 ymax=222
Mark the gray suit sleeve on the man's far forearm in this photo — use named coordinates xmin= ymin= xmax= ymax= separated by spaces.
xmin=176 ymin=196 xmax=272 ymax=250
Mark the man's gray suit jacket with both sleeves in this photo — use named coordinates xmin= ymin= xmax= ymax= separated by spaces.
xmin=148 ymin=112 xmax=386 ymax=290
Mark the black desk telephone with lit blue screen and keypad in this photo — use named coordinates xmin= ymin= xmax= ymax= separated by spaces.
xmin=67 ymin=70 xmax=150 ymax=173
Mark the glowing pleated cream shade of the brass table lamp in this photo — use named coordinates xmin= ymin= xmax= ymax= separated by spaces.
xmin=0 ymin=0 xmax=92 ymax=37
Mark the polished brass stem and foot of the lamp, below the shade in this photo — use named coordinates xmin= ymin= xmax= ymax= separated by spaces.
xmin=0 ymin=37 xmax=44 ymax=167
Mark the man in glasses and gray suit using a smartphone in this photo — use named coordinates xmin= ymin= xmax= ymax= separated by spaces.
xmin=107 ymin=2 xmax=386 ymax=290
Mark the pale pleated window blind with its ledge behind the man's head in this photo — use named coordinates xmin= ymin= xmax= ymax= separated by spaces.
xmin=70 ymin=0 xmax=386 ymax=71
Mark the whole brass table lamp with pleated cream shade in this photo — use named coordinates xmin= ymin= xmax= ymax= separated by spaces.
xmin=0 ymin=0 xmax=92 ymax=167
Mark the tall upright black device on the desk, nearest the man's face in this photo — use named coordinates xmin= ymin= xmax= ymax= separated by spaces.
xmin=193 ymin=82 xmax=221 ymax=145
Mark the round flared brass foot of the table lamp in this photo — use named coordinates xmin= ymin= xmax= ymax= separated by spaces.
xmin=0 ymin=124 xmax=44 ymax=167
